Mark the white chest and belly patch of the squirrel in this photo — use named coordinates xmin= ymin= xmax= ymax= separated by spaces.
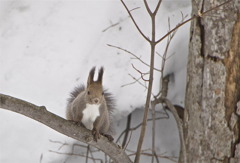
xmin=82 ymin=104 xmax=100 ymax=130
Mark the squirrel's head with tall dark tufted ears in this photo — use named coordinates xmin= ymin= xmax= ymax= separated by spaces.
xmin=86 ymin=67 xmax=104 ymax=105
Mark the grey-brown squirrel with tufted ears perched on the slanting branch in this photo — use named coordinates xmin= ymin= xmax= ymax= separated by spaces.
xmin=66 ymin=67 xmax=115 ymax=141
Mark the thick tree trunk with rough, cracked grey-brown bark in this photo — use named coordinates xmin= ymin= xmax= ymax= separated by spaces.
xmin=184 ymin=0 xmax=240 ymax=163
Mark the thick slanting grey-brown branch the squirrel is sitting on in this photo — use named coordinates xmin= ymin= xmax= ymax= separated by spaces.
xmin=0 ymin=94 xmax=132 ymax=163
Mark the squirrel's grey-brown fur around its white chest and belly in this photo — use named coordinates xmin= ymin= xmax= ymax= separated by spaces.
xmin=66 ymin=67 xmax=115 ymax=140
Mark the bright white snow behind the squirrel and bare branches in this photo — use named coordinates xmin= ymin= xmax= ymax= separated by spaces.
xmin=0 ymin=0 xmax=191 ymax=163
